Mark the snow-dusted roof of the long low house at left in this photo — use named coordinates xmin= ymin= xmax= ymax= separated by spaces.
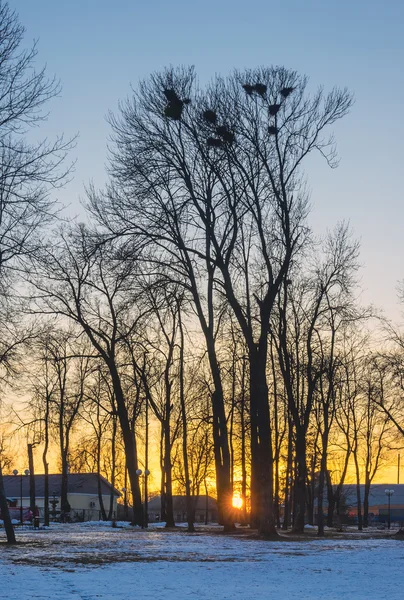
xmin=3 ymin=473 xmax=121 ymax=498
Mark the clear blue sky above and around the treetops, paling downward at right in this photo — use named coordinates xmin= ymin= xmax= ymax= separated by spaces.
xmin=15 ymin=0 xmax=404 ymax=317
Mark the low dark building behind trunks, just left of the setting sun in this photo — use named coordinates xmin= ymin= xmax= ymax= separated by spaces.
xmin=148 ymin=495 xmax=218 ymax=523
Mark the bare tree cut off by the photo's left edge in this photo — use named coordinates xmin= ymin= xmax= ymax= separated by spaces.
xmin=0 ymin=0 xmax=71 ymax=542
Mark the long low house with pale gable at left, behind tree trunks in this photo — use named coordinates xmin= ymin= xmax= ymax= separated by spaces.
xmin=3 ymin=473 xmax=121 ymax=521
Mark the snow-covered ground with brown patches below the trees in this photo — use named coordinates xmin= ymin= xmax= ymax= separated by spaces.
xmin=0 ymin=524 xmax=404 ymax=600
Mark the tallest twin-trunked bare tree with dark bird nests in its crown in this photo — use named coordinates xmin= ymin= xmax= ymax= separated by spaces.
xmin=90 ymin=68 xmax=351 ymax=535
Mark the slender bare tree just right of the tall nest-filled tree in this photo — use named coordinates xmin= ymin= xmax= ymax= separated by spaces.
xmin=278 ymin=224 xmax=358 ymax=533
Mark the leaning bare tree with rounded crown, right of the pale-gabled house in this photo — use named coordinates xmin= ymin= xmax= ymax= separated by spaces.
xmin=29 ymin=227 xmax=149 ymax=525
